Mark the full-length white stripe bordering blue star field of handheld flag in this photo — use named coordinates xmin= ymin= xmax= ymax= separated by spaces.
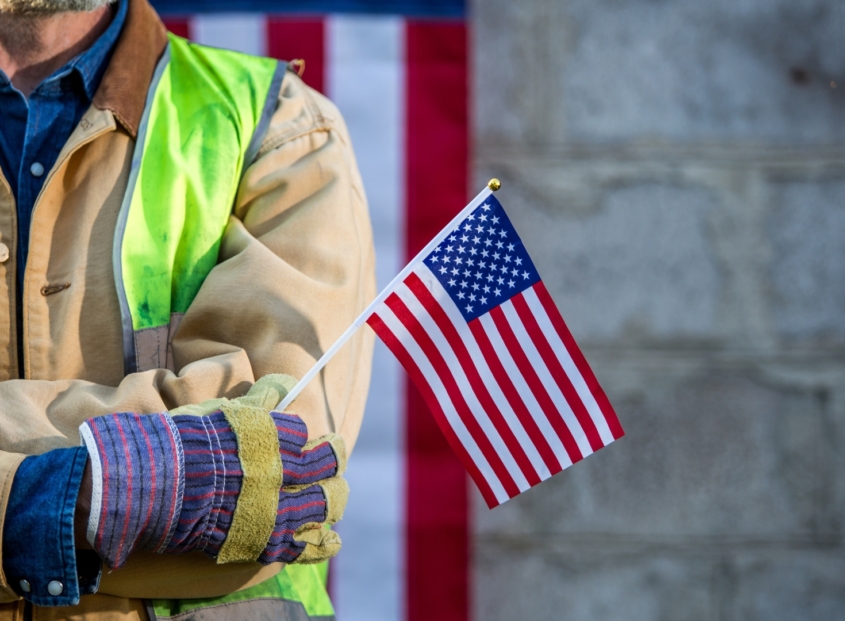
xmin=414 ymin=263 xmax=551 ymax=480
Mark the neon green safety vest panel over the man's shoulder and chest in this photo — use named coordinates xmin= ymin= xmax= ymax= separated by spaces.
xmin=113 ymin=35 xmax=286 ymax=374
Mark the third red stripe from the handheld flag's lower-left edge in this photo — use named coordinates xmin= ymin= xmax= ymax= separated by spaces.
xmin=405 ymin=274 xmax=540 ymax=487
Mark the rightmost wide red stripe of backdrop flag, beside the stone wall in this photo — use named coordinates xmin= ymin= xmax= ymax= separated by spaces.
xmin=405 ymin=20 xmax=470 ymax=621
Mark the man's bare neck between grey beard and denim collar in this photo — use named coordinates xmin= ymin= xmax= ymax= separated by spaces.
xmin=0 ymin=6 xmax=113 ymax=97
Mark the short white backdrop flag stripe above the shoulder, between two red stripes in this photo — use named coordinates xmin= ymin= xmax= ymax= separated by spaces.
xmin=191 ymin=13 xmax=267 ymax=56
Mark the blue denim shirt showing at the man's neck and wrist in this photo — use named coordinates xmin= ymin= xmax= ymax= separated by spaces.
xmin=0 ymin=0 xmax=128 ymax=606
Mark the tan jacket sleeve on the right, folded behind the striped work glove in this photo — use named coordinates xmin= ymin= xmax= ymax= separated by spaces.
xmin=0 ymin=73 xmax=375 ymax=603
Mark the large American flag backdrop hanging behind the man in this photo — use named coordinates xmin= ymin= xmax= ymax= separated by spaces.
xmin=153 ymin=0 xmax=474 ymax=621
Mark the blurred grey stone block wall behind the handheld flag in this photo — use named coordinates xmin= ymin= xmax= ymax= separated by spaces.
xmin=472 ymin=0 xmax=845 ymax=621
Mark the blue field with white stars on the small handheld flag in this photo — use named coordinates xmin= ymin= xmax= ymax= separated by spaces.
xmin=423 ymin=196 xmax=540 ymax=323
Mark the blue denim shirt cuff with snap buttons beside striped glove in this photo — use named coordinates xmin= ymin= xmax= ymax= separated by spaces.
xmin=3 ymin=447 xmax=101 ymax=606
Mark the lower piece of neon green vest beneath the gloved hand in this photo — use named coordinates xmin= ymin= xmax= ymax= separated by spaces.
xmin=149 ymin=562 xmax=334 ymax=621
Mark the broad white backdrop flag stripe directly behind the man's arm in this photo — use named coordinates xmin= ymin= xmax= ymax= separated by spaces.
xmin=325 ymin=16 xmax=406 ymax=621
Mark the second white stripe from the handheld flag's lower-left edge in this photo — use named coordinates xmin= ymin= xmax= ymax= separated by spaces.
xmin=395 ymin=283 xmax=531 ymax=492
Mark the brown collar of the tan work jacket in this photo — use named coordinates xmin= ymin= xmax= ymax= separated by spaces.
xmin=93 ymin=0 xmax=167 ymax=138
